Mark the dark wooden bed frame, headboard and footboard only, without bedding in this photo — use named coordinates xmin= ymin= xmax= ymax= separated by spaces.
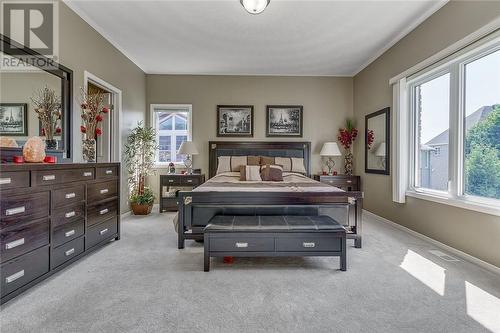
xmin=178 ymin=141 xmax=363 ymax=249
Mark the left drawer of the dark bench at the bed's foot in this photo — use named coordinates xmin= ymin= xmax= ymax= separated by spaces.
xmin=210 ymin=236 xmax=274 ymax=252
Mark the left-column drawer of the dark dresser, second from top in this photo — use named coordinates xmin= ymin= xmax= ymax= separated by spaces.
xmin=0 ymin=192 xmax=49 ymax=224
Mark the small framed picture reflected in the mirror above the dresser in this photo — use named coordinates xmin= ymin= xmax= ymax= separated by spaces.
xmin=0 ymin=103 xmax=28 ymax=136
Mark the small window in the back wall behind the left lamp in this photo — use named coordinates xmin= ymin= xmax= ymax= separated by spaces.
xmin=151 ymin=104 xmax=192 ymax=165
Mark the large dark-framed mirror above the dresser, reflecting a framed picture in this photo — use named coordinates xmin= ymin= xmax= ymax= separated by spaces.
xmin=0 ymin=34 xmax=73 ymax=162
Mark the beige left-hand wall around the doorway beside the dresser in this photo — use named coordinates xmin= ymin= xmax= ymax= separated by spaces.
xmin=59 ymin=2 xmax=146 ymax=212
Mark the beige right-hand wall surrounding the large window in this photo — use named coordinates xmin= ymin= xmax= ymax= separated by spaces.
xmin=354 ymin=1 xmax=500 ymax=266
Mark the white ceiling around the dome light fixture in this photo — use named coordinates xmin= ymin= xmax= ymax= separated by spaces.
xmin=65 ymin=0 xmax=446 ymax=76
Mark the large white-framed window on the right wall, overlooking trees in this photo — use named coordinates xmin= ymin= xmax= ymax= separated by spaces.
xmin=398 ymin=33 xmax=500 ymax=215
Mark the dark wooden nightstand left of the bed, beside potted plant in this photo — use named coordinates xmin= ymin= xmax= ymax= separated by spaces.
xmin=160 ymin=174 xmax=205 ymax=213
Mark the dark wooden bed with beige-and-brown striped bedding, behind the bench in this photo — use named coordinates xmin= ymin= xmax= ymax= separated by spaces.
xmin=177 ymin=141 xmax=363 ymax=249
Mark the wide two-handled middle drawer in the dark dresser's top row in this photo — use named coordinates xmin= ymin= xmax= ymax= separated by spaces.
xmin=31 ymin=167 xmax=94 ymax=186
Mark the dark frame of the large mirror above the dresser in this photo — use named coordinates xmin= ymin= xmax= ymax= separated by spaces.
xmin=0 ymin=34 xmax=73 ymax=160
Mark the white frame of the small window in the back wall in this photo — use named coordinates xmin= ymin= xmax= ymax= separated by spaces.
xmin=149 ymin=104 xmax=193 ymax=168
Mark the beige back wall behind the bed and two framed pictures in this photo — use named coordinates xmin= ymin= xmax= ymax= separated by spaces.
xmin=146 ymin=75 xmax=352 ymax=198
